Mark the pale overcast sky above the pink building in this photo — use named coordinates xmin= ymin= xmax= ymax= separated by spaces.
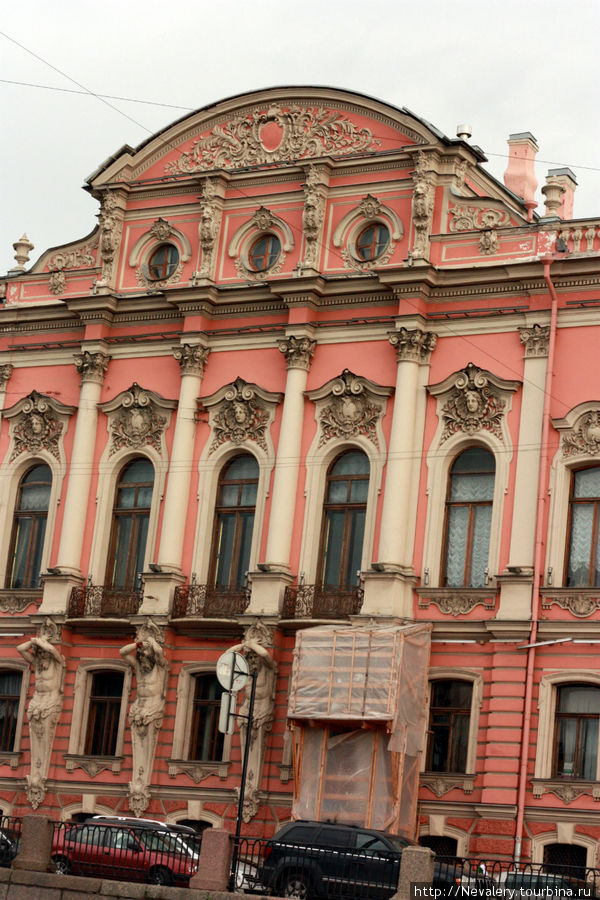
xmin=0 ymin=0 xmax=600 ymax=273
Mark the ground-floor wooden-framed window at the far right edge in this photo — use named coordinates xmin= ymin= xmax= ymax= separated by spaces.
xmin=553 ymin=684 xmax=600 ymax=781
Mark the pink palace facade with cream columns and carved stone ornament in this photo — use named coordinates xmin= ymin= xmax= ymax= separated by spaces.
xmin=0 ymin=88 xmax=600 ymax=865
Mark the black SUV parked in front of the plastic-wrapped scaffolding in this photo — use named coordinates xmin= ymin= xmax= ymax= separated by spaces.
xmin=257 ymin=821 xmax=460 ymax=900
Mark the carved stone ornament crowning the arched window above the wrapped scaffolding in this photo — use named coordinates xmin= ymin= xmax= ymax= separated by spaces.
xmin=306 ymin=369 xmax=392 ymax=449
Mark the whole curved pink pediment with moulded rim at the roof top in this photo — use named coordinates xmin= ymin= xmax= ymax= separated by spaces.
xmin=89 ymin=87 xmax=441 ymax=188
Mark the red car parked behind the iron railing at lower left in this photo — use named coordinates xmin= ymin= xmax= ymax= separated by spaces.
xmin=52 ymin=822 xmax=198 ymax=887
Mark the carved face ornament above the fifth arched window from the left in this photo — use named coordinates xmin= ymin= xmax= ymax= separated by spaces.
xmin=428 ymin=363 xmax=519 ymax=443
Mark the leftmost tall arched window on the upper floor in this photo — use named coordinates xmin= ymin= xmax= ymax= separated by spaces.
xmin=6 ymin=465 xmax=52 ymax=588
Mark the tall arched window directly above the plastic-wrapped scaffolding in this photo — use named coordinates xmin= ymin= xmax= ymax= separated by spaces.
xmin=318 ymin=450 xmax=370 ymax=588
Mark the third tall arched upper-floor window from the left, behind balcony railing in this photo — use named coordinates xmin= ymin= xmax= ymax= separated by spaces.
xmin=209 ymin=454 xmax=258 ymax=591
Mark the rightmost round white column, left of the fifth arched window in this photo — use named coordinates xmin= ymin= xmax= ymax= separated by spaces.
xmin=378 ymin=328 xmax=436 ymax=569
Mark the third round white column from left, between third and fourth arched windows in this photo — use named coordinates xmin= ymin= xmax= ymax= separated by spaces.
xmin=266 ymin=334 xmax=316 ymax=571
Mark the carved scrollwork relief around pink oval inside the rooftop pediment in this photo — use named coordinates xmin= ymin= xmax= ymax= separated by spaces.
xmin=165 ymin=105 xmax=381 ymax=175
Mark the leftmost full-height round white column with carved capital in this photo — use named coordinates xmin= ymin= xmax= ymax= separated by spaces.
xmin=57 ymin=350 xmax=109 ymax=575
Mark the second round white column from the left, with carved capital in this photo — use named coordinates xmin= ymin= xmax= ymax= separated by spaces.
xmin=157 ymin=344 xmax=209 ymax=571
